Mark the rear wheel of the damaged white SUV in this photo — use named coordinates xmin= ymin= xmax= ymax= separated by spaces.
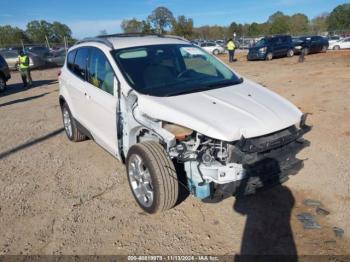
xmin=61 ymin=103 xmax=86 ymax=142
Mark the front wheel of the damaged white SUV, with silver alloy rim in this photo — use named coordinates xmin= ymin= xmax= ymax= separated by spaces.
xmin=126 ymin=141 xmax=179 ymax=214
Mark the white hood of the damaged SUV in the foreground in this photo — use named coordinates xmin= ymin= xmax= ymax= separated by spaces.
xmin=138 ymin=79 xmax=302 ymax=141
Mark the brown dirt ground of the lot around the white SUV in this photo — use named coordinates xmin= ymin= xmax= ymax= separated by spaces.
xmin=0 ymin=51 xmax=350 ymax=255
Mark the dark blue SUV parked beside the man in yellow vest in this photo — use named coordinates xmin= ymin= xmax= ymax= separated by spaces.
xmin=247 ymin=35 xmax=294 ymax=60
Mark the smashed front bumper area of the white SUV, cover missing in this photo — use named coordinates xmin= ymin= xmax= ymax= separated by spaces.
xmin=185 ymin=124 xmax=311 ymax=201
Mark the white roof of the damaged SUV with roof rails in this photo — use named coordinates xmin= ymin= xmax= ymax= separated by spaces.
xmin=77 ymin=34 xmax=190 ymax=49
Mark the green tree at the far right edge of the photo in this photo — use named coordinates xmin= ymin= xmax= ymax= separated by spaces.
xmin=327 ymin=4 xmax=350 ymax=30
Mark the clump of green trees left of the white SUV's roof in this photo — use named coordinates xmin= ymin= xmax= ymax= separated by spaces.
xmin=0 ymin=20 xmax=75 ymax=47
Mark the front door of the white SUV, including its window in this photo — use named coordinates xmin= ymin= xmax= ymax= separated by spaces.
xmin=86 ymin=47 xmax=119 ymax=156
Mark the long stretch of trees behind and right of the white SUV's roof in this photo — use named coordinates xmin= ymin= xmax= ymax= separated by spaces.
xmin=121 ymin=4 xmax=350 ymax=39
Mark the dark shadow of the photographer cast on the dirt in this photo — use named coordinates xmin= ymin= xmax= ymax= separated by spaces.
xmin=233 ymin=186 xmax=297 ymax=261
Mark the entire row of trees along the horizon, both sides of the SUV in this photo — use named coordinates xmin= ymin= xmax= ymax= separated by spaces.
xmin=0 ymin=4 xmax=350 ymax=47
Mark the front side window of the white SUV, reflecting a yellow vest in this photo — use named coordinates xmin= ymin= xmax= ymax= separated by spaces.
xmin=87 ymin=48 xmax=114 ymax=95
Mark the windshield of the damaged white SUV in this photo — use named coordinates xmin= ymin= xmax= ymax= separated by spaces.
xmin=113 ymin=44 xmax=242 ymax=96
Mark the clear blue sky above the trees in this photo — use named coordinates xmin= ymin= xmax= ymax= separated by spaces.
xmin=0 ymin=0 xmax=350 ymax=38
